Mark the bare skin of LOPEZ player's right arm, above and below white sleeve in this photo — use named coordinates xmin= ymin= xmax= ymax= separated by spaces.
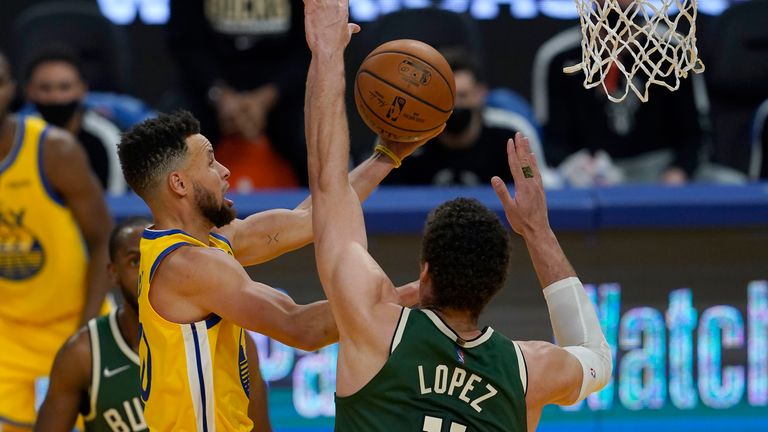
xmin=491 ymin=133 xmax=583 ymax=431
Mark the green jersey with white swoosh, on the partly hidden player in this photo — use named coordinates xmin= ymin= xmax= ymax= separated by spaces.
xmin=83 ymin=311 xmax=149 ymax=432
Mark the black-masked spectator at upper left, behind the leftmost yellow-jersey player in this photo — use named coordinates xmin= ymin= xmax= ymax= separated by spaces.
xmin=24 ymin=47 xmax=126 ymax=195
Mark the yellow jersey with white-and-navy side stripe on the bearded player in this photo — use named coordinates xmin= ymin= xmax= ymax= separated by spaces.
xmin=139 ymin=229 xmax=253 ymax=432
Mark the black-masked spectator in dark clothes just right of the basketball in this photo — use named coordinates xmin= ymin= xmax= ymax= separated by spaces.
xmin=385 ymin=49 xmax=517 ymax=186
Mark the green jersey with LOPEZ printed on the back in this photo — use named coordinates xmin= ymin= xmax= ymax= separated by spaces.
xmin=336 ymin=308 xmax=527 ymax=432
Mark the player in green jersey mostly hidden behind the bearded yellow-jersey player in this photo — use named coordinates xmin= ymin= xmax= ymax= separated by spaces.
xmin=35 ymin=217 xmax=272 ymax=432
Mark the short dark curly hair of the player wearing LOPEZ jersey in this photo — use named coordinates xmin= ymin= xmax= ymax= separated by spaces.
xmin=421 ymin=198 xmax=509 ymax=318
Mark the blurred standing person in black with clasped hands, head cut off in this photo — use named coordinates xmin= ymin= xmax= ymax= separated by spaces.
xmin=169 ymin=0 xmax=309 ymax=184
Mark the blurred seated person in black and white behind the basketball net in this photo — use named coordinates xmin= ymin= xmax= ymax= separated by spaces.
xmin=532 ymin=27 xmax=707 ymax=186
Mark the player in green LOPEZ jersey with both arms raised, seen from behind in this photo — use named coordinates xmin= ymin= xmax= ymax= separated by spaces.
xmin=304 ymin=0 xmax=612 ymax=432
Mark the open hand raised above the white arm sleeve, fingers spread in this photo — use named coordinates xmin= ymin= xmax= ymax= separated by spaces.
xmin=491 ymin=132 xmax=549 ymax=237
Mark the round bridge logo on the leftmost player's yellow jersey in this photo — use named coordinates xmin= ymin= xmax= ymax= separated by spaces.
xmin=0 ymin=209 xmax=45 ymax=281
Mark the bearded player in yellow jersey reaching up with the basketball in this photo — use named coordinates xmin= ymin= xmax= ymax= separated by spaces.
xmin=119 ymin=112 xmax=419 ymax=431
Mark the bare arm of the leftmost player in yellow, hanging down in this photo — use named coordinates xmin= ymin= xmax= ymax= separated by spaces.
xmin=43 ymin=128 xmax=112 ymax=324
